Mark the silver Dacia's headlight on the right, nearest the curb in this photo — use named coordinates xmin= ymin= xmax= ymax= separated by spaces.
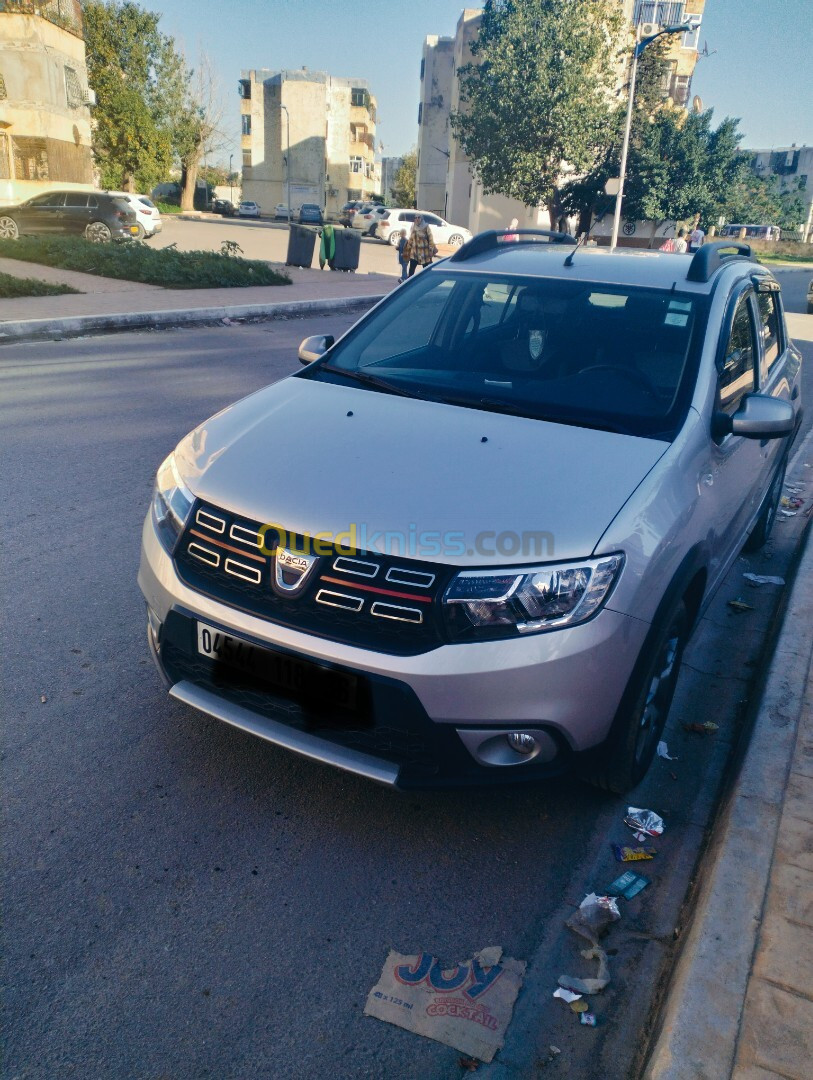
xmin=443 ymin=555 xmax=624 ymax=640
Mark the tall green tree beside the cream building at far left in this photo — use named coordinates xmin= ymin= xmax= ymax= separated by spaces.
xmin=83 ymin=0 xmax=187 ymax=191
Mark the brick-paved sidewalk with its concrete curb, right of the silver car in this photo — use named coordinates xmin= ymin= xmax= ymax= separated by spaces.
xmin=643 ymin=516 xmax=813 ymax=1080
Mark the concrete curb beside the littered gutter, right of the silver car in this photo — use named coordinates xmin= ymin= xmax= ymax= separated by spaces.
xmin=642 ymin=520 xmax=813 ymax=1080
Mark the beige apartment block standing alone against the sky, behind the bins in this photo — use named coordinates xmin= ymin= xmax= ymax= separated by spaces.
xmin=240 ymin=68 xmax=381 ymax=214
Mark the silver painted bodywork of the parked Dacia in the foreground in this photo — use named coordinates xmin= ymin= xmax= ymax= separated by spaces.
xmin=139 ymin=245 xmax=800 ymax=783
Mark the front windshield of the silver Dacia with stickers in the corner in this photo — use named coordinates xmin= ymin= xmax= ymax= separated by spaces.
xmin=300 ymin=266 xmax=706 ymax=440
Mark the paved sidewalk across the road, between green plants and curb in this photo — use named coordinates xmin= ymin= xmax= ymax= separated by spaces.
xmin=0 ymin=259 xmax=397 ymax=342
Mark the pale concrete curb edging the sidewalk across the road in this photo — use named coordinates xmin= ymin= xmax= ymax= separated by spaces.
xmin=0 ymin=294 xmax=384 ymax=345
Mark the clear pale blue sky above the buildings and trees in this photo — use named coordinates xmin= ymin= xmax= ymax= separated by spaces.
xmin=152 ymin=0 xmax=813 ymax=162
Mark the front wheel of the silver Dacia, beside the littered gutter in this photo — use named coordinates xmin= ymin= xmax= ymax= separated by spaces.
xmin=583 ymin=599 xmax=691 ymax=795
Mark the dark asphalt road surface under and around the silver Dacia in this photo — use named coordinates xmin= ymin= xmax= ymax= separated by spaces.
xmin=0 ymin=316 xmax=813 ymax=1080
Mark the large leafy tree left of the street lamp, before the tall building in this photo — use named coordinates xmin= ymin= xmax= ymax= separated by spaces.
xmin=451 ymin=0 xmax=624 ymax=222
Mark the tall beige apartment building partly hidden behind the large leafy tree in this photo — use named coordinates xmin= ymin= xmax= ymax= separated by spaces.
xmin=417 ymin=0 xmax=705 ymax=232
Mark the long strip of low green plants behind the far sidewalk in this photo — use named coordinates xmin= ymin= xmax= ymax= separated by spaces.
xmin=0 ymin=237 xmax=290 ymax=288
